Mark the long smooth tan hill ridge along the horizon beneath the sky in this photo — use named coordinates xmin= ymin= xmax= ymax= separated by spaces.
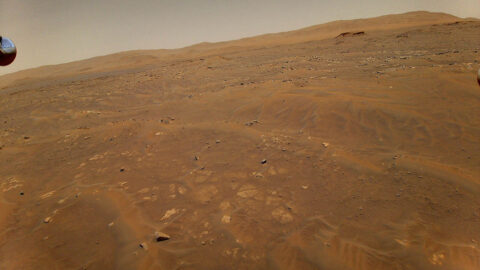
xmin=0 ymin=11 xmax=464 ymax=89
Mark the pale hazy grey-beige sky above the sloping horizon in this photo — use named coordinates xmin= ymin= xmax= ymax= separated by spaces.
xmin=0 ymin=0 xmax=480 ymax=75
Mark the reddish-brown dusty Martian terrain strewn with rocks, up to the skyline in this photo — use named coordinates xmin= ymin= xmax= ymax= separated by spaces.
xmin=0 ymin=13 xmax=480 ymax=270
